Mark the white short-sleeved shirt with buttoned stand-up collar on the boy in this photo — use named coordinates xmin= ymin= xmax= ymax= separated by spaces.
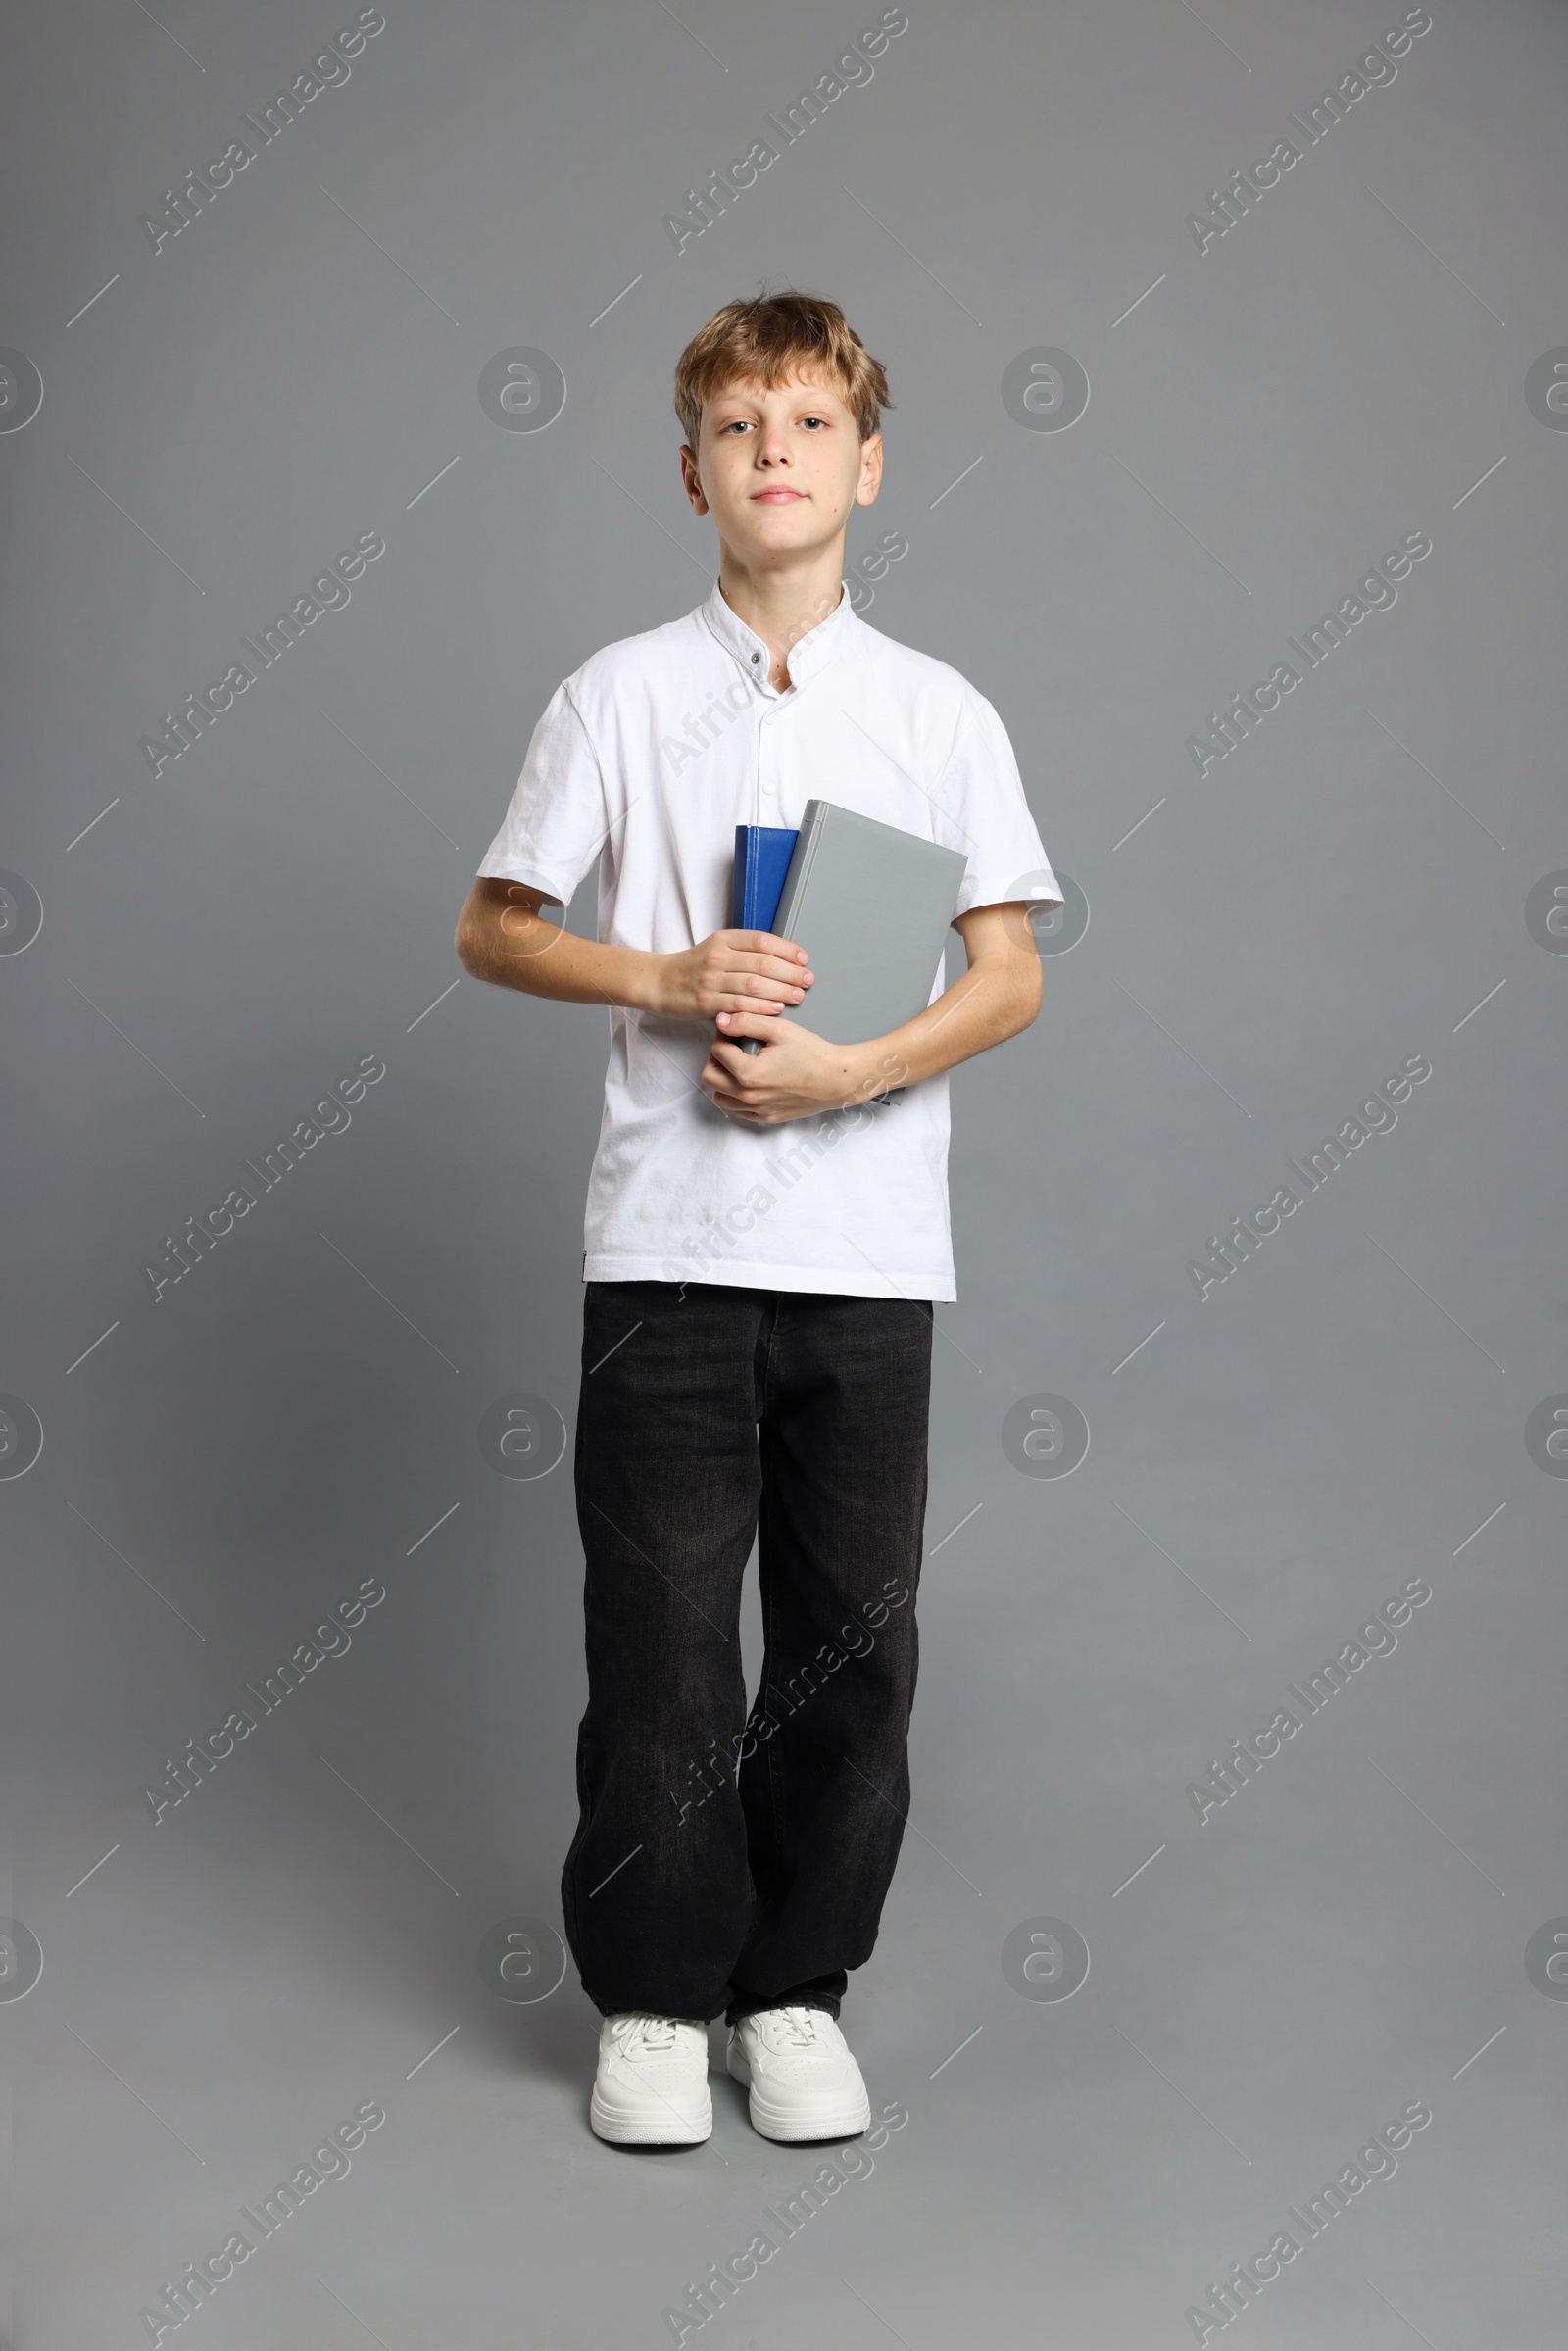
xmin=479 ymin=583 xmax=1062 ymax=1298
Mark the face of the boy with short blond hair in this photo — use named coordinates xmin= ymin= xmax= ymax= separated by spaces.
xmin=682 ymin=373 xmax=882 ymax=571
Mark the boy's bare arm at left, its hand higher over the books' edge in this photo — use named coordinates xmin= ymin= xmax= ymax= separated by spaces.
xmin=454 ymin=874 xmax=811 ymax=1020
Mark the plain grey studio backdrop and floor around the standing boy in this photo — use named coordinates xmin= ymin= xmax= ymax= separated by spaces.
xmin=0 ymin=0 xmax=1568 ymax=2351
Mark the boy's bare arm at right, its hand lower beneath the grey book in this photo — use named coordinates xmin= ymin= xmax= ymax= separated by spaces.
xmin=703 ymin=901 xmax=1044 ymax=1126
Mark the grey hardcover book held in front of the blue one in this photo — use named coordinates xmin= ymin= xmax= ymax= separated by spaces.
xmin=743 ymin=800 xmax=968 ymax=1071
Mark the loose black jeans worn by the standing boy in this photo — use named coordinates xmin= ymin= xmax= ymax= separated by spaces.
xmin=562 ymin=1281 xmax=933 ymax=2025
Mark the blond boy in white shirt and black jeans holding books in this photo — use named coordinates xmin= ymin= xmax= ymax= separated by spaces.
xmin=456 ymin=294 xmax=1062 ymax=2144
